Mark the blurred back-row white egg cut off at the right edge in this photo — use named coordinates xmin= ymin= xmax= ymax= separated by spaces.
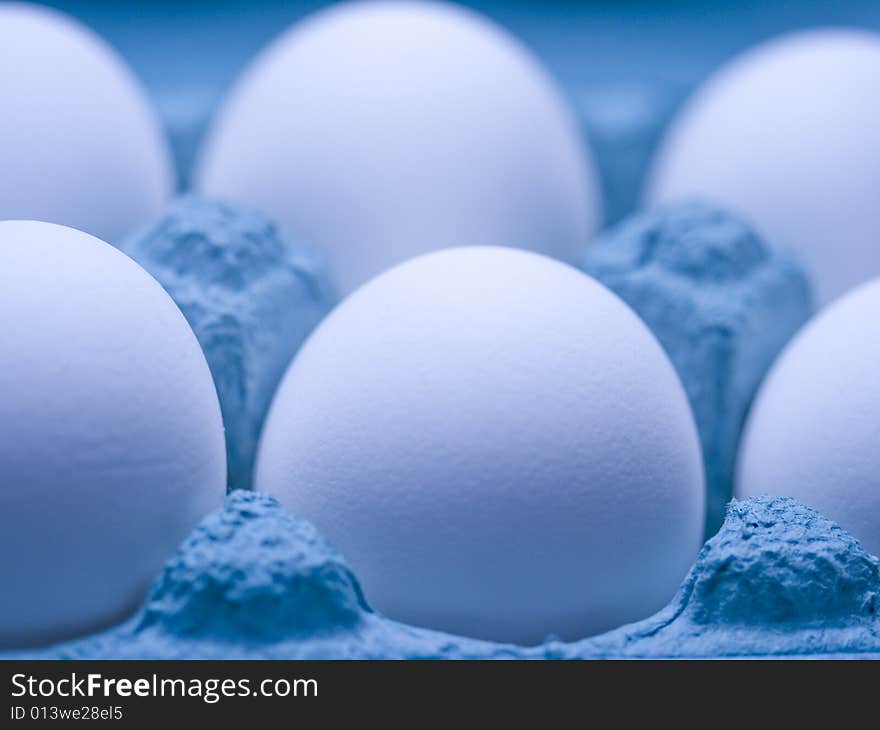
xmin=645 ymin=29 xmax=880 ymax=304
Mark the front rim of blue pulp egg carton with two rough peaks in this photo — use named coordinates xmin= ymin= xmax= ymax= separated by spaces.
xmin=0 ymin=491 xmax=880 ymax=659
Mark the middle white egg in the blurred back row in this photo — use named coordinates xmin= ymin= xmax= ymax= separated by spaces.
xmin=195 ymin=2 xmax=600 ymax=293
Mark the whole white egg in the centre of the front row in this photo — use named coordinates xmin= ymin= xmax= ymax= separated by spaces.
xmin=255 ymin=247 xmax=705 ymax=643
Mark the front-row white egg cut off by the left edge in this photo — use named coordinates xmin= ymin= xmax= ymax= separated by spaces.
xmin=0 ymin=221 xmax=226 ymax=648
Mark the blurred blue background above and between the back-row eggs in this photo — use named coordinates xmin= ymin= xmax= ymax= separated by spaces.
xmin=34 ymin=0 xmax=880 ymax=222
